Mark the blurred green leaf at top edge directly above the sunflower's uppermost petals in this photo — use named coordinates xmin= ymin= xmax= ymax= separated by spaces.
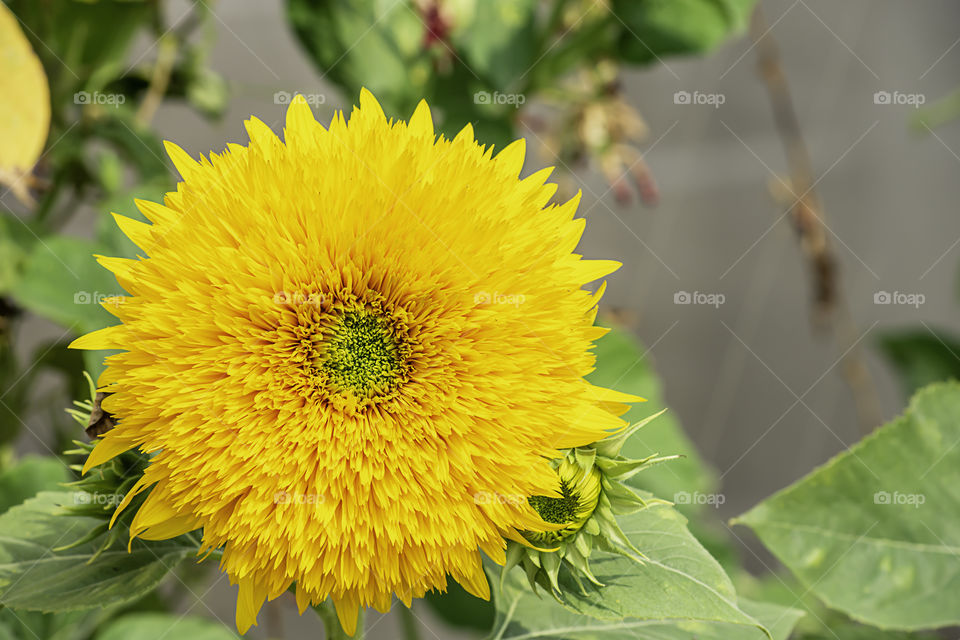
xmin=287 ymin=0 xmax=433 ymax=117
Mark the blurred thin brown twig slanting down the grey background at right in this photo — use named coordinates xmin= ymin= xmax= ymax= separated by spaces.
xmin=750 ymin=6 xmax=883 ymax=435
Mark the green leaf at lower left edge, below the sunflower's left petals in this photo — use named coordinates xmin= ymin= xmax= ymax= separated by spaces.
xmin=0 ymin=492 xmax=197 ymax=612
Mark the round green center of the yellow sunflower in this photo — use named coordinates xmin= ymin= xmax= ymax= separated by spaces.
xmin=319 ymin=310 xmax=404 ymax=398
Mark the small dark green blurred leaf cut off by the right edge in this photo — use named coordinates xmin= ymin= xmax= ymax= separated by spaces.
xmin=880 ymin=329 xmax=960 ymax=396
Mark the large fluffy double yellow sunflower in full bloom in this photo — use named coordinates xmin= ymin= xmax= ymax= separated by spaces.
xmin=73 ymin=91 xmax=638 ymax=635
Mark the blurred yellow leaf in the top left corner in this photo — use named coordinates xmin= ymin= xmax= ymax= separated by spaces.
xmin=0 ymin=2 xmax=50 ymax=179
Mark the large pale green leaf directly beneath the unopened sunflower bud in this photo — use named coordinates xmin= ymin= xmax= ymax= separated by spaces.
xmin=494 ymin=505 xmax=768 ymax=640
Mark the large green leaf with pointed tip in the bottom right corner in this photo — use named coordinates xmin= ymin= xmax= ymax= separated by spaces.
xmin=738 ymin=383 xmax=960 ymax=630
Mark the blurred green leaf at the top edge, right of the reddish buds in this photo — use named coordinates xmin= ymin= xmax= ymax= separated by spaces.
xmin=613 ymin=0 xmax=757 ymax=64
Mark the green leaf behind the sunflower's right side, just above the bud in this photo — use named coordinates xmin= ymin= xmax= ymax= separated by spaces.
xmin=588 ymin=329 xmax=715 ymax=502
